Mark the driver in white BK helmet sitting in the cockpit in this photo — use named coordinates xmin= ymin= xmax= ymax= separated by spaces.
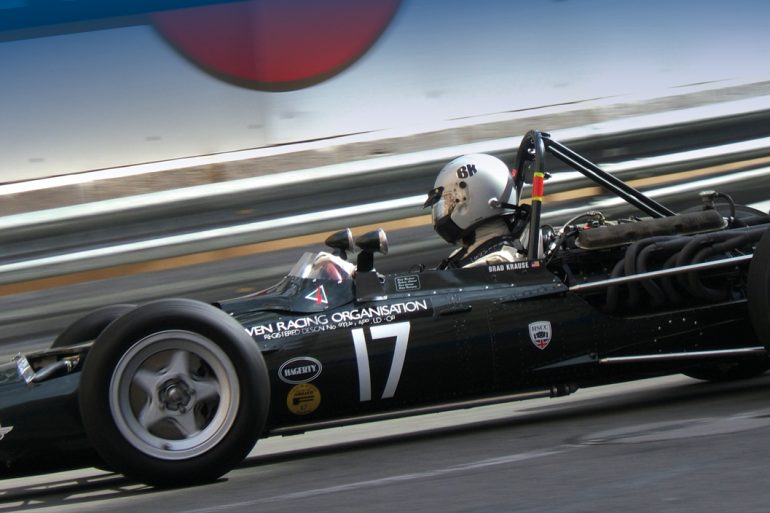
xmin=424 ymin=154 xmax=529 ymax=269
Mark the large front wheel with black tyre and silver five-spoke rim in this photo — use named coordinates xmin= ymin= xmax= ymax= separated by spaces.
xmin=79 ymin=299 xmax=270 ymax=486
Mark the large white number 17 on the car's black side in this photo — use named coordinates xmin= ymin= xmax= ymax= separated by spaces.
xmin=351 ymin=322 xmax=410 ymax=401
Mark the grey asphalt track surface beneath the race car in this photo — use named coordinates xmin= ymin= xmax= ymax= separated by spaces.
xmin=0 ymin=375 xmax=770 ymax=513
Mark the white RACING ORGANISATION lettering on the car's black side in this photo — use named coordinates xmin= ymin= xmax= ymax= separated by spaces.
xmin=246 ymin=299 xmax=430 ymax=340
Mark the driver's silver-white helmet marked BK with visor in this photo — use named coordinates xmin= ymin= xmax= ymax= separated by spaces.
xmin=424 ymin=153 xmax=517 ymax=244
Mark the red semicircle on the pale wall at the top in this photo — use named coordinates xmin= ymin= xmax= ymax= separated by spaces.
xmin=152 ymin=0 xmax=399 ymax=91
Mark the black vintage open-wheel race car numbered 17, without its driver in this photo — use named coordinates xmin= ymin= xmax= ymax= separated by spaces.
xmin=0 ymin=131 xmax=770 ymax=486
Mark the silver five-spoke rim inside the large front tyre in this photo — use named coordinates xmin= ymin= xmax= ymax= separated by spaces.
xmin=109 ymin=330 xmax=240 ymax=460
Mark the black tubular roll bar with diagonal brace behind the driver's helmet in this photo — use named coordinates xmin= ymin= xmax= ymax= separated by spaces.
xmin=513 ymin=130 xmax=676 ymax=260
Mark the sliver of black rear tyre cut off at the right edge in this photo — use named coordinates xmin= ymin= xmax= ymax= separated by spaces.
xmin=746 ymin=228 xmax=770 ymax=350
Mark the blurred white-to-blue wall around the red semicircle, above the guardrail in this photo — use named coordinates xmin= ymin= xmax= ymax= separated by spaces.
xmin=0 ymin=0 xmax=770 ymax=182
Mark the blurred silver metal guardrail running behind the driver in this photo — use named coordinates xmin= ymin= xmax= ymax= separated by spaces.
xmin=0 ymin=99 xmax=770 ymax=283
